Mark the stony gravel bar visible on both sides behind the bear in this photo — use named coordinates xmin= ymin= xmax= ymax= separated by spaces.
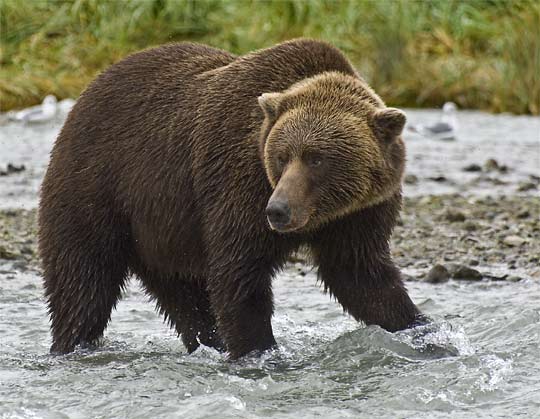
xmin=0 ymin=194 xmax=540 ymax=283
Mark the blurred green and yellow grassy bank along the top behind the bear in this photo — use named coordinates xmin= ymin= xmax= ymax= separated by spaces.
xmin=0 ymin=0 xmax=540 ymax=114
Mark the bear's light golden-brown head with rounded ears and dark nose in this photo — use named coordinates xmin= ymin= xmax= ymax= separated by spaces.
xmin=258 ymin=72 xmax=405 ymax=233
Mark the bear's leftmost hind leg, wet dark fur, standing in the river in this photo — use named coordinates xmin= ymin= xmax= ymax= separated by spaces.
xmin=43 ymin=243 xmax=127 ymax=353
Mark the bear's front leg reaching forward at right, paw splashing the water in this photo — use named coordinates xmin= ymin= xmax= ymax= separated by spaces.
xmin=312 ymin=204 xmax=428 ymax=332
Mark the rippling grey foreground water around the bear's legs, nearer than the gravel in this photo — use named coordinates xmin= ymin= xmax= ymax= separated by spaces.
xmin=0 ymin=266 xmax=540 ymax=419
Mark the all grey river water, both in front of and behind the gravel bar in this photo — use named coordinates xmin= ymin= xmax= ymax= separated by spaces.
xmin=0 ymin=106 xmax=540 ymax=419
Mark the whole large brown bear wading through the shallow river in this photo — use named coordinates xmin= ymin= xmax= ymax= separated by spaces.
xmin=39 ymin=40 xmax=421 ymax=359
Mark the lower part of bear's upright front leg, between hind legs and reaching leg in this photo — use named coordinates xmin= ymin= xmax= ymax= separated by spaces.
xmin=209 ymin=262 xmax=276 ymax=359
